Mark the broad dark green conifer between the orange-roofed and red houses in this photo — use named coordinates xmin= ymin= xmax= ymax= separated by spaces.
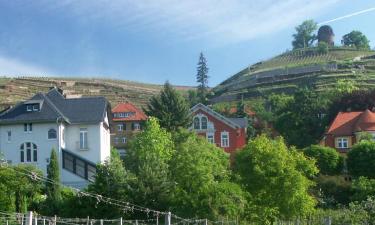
xmin=144 ymin=82 xmax=191 ymax=131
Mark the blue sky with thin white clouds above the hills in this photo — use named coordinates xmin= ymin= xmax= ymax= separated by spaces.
xmin=0 ymin=0 xmax=375 ymax=86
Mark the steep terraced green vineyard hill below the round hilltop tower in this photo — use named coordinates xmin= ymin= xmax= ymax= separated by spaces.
xmin=211 ymin=47 xmax=375 ymax=103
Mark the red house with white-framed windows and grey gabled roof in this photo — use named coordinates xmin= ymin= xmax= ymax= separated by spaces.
xmin=190 ymin=103 xmax=247 ymax=153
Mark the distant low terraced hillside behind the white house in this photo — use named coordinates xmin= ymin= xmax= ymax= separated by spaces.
xmin=0 ymin=77 xmax=191 ymax=109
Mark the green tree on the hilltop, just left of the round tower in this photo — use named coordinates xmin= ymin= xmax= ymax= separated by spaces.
xmin=292 ymin=20 xmax=318 ymax=49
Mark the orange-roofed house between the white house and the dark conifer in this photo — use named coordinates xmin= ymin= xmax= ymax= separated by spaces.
xmin=111 ymin=102 xmax=147 ymax=157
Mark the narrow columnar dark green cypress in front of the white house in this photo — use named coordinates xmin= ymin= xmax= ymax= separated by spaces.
xmin=46 ymin=149 xmax=61 ymax=215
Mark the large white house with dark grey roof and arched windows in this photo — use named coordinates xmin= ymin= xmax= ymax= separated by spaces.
xmin=0 ymin=88 xmax=110 ymax=188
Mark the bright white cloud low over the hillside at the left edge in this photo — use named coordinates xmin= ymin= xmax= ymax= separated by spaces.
xmin=0 ymin=55 xmax=51 ymax=76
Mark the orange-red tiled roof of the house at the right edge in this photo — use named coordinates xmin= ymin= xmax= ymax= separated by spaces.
xmin=327 ymin=109 xmax=375 ymax=136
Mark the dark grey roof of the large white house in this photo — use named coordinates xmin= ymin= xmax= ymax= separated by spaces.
xmin=0 ymin=88 xmax=109 ymax=124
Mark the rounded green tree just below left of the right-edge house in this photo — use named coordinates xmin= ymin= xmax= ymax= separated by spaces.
xmin=303 ymin=145 xmax=344 ymax=175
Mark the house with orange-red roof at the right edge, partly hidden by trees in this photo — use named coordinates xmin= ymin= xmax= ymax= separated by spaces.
xmin=321 ymin=110 xmax=375 ymax=154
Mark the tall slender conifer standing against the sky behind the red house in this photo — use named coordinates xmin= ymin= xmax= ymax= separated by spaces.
xmin=197 ymin=52 xmax=208 ymax=104
